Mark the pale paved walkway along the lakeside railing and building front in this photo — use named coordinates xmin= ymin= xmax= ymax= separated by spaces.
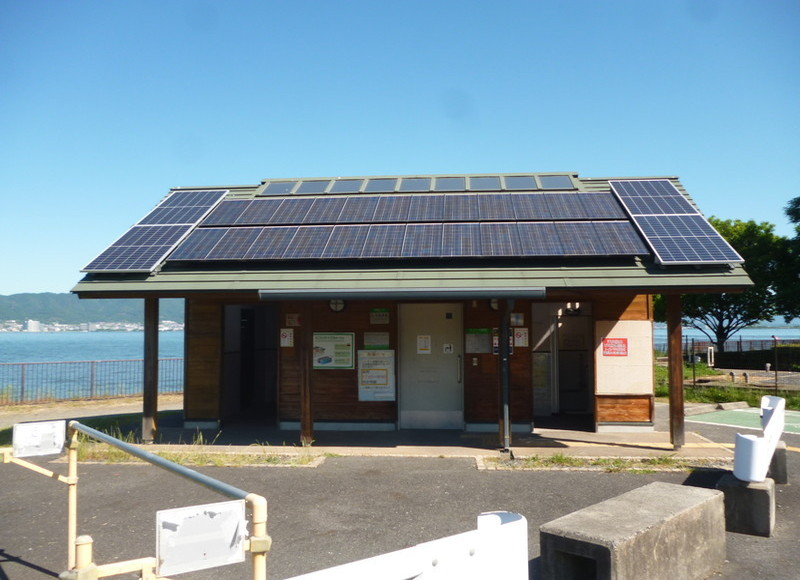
xmin=0 ymin=397 xmax=733 ymax=463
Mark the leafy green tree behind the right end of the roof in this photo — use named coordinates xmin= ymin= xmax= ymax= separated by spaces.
xmin=656 ymin=217 xmax=788 ymax=352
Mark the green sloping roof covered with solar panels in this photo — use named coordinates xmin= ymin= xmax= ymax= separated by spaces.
xmin=73 ymin=173 xmax=750 ymax=298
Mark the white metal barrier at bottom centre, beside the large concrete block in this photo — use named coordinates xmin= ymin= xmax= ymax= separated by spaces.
xmin=289 ymin=512 xmax=528 ymax=580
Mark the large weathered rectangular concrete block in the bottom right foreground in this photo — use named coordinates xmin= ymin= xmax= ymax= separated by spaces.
xmin=539 ymin=482 xmax=726 ymax=580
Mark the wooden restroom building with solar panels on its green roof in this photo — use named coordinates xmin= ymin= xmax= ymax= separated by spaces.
xmin=73 ymin=173 xmax=751 ymax=441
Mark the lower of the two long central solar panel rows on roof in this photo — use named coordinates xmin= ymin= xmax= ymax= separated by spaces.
xmin=169 ymin=220 xmax=649 ymax=261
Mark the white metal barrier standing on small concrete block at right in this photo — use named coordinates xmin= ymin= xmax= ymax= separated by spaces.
xmin=733 ymin=395 xmax=786 ymax=483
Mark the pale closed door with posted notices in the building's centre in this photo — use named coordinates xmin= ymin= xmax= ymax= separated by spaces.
xmin=399 ymin=304 xmax=464 ymax=429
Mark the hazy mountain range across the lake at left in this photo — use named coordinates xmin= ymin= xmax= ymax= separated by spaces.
xmin=0 ymin=292 xmax=183 ymax=324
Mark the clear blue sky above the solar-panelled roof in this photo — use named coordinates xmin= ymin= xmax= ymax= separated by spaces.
xmin=0 ymin=0 xmax=800 ymax=294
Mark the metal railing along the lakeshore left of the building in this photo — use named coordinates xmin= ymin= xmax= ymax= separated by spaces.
xmin=0 ymin=358 xmax=183 ymax=405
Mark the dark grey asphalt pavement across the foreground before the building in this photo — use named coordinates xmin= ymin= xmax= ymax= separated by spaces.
xmin=0 ymin=409 xmax=800 ymax=580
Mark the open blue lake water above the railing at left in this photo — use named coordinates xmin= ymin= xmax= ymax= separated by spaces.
xmin=0 ymin=331 xmax=183 ymax=363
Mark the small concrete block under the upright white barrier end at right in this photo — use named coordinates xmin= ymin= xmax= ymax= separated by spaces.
xmin=717 ymin=473 xmax=775 ymax=537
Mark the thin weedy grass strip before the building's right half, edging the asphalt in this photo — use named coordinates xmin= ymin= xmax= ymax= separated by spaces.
xmin=486 ymin=453 xmax=717 ymax=473
